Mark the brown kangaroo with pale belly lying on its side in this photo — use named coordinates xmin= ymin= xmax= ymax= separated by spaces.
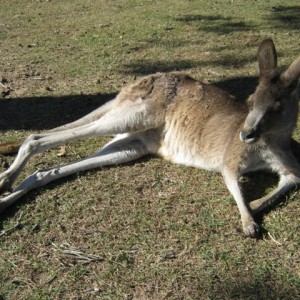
xmin=0 ymin=39 xmax=300 ymax=237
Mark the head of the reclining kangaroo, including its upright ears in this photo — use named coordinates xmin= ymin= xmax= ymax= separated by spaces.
xmin=240 ymin=39 xmax=300 ymax=144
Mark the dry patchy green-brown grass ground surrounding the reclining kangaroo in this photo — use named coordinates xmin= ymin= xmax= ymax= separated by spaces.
xmin=0 ymin=0 xmax=300 ymax=299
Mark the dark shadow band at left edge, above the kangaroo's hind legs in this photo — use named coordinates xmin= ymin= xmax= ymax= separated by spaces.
xmin=0 ymin=93 xmax=115 ymax=131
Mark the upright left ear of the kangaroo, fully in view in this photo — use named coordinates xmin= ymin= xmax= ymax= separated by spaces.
xmin=257 ymin=39 xmax=277 ymax=77
